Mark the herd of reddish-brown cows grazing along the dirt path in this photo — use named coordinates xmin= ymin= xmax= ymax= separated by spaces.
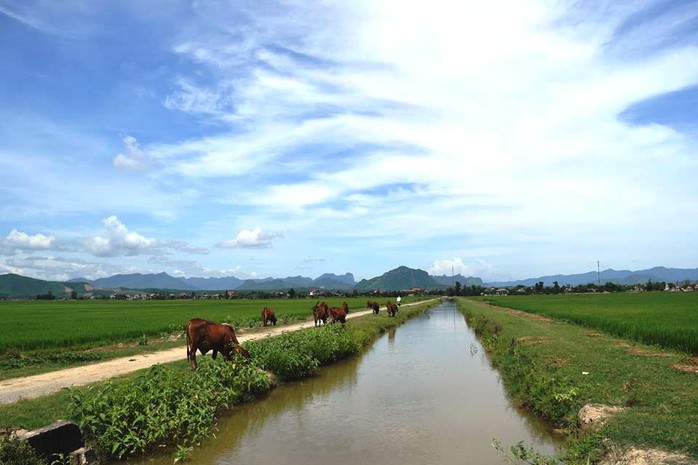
xmin=185 ymin=300 xmax=398 ymax=370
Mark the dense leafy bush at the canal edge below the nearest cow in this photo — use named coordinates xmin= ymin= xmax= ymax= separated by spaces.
xmin=69 ymin=359 xmax=271 ymax=459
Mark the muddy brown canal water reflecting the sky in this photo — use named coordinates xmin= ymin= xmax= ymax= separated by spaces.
xmin=136 ymin=303 xmax=555 ymax=465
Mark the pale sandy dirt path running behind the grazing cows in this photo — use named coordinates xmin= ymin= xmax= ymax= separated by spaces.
xmin=0 ymin=302 xmax=423 ymax=404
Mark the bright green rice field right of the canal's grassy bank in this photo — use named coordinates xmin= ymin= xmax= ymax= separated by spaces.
xmin=486 ymin=292 xmax=698 ymax=355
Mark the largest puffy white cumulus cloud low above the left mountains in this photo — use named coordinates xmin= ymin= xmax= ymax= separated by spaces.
xmin=85 ymin=215 xmax=160 ymax=257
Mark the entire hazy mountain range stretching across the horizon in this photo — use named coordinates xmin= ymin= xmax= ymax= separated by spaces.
xmin=0 ymin=266 xmax=698 ymax=298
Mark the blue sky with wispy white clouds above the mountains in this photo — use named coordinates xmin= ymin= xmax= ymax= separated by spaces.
xmin=0 ymin=0 xmax=698 ymax=280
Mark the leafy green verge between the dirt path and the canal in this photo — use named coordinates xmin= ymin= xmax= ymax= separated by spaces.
xmin=0 ymin=298 xmax=436 ymax=458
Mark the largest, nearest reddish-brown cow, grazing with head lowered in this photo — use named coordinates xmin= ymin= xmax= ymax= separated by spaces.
xmin=186 ymin=318 xmax=250 ymax=370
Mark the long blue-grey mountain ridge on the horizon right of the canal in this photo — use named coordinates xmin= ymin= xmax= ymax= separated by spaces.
xmin=487 ymin=266 xmax=698 ymax=287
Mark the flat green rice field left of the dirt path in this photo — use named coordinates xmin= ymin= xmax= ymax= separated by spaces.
xmin=0 ymin=297 xmax=376 ymax=355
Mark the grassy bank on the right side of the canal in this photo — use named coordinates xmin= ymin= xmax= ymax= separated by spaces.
xmin=458 ymin=298 xmax=698 ymax=463
